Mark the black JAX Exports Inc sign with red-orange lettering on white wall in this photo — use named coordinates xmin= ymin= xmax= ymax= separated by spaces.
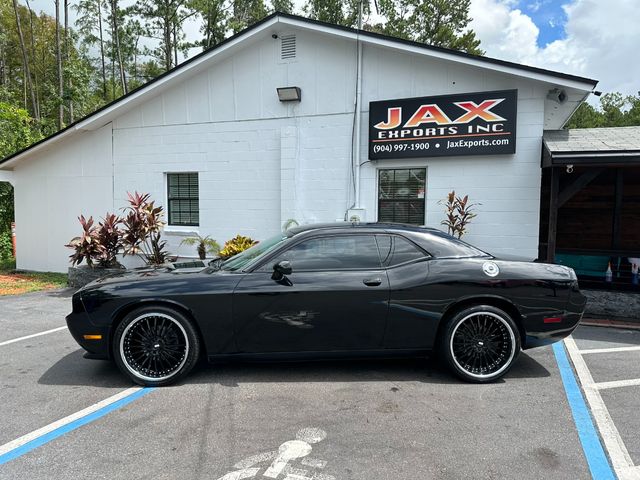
xmin=369 ymin=90 xmax=518 ymax=160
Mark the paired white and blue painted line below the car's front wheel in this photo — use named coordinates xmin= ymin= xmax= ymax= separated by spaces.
xmin=0 ymin=387 xmax=155 ymax=465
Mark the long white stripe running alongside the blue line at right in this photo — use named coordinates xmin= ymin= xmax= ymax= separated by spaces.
xmin=564 ymin=336 xmax=640 ymax=480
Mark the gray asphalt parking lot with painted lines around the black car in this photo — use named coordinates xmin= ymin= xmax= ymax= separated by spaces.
xmin=0 ymin=292 xmax=640 ymax=480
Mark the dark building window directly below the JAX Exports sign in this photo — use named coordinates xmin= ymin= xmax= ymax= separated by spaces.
xmin=378 ymin=168 xmax=427 ymax=225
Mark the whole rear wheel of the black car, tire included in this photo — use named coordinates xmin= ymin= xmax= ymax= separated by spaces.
xmin=440 ymin=305 xmax=520 ymax=383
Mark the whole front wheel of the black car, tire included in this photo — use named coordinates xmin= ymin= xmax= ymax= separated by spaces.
xmin=113 ymin=306 xmax=200 ymax=387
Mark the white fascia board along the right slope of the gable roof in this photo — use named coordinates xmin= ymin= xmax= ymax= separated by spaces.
xmin=279 ymin=18 xmax=594 ymax=92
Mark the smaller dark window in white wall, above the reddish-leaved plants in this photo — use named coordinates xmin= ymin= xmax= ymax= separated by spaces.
xmin=167 ymin=173 xmax=200 ymax=226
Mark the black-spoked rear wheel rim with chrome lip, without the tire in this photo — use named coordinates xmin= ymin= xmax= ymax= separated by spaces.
xmin=449 ymin=311 xmax=518 ymax=380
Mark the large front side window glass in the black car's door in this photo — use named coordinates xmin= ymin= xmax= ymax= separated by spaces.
xmin=260 ymin=235 xmax=381 ymax=273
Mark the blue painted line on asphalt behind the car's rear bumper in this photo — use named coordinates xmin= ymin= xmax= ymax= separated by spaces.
xmin=553 ymin=342 xmax=616 ymax=480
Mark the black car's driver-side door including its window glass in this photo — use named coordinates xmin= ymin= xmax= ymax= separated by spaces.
xmin=233 ymin=234 xmax=389 ymax=353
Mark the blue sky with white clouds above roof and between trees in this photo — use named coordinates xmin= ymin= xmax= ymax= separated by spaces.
xmin=27 ymin=0 xmax=640 ymax=101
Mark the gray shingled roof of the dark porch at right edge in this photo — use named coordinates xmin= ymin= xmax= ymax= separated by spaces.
xmin=542 ymin=126 xmax=640 ymax=155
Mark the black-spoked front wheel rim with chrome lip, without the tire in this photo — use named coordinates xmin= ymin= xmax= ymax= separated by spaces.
xmin=119 ymin=312 xmax=190 ymax=382
